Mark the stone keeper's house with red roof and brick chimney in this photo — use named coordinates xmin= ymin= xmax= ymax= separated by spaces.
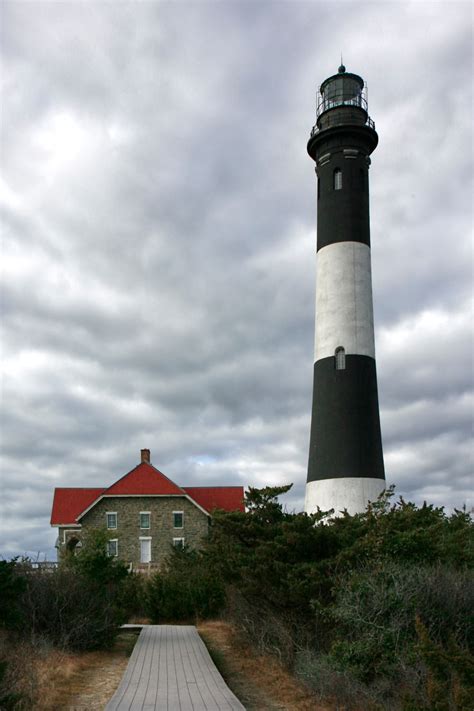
xmin=51 ymin=449 xmax=244 ymax=567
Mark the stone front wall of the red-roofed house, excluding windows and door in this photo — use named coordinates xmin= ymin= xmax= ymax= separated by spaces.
xmin=60 ymin=496 xmax=210 ymax=565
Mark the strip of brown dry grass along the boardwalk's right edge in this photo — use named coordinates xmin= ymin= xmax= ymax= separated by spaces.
xmin=198 ymin=622 xmax=333 ymax=711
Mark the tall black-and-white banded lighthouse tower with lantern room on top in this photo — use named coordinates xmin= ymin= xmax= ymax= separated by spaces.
xmin=305 ymin=65 xmax=385 ymax=514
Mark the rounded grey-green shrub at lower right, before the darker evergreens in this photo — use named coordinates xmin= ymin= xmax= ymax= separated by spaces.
xmin=319 ymin=562 xmax=474 ymax=681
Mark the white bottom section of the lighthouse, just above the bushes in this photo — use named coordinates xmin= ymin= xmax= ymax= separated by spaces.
xmin=304 ymin=477 xmax=385 ymax=516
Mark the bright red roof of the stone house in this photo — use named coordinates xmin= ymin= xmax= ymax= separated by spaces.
xmin=51 ymin=462 xmax=245 ymax=526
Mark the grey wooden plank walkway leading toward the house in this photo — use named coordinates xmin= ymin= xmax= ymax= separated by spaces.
xmin=105 ymin=625 xmax=245 ymax=711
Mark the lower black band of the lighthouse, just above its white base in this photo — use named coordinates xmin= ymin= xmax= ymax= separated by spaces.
xmin=308 ymin=355 xmax=385 ymax=482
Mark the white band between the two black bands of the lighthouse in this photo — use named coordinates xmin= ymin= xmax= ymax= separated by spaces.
xmin=314 ymin=242 xmax=375 ymax=361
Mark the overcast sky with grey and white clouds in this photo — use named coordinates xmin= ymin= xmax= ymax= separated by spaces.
xmin=0 ymin=0 xmax=473 ymax=558
